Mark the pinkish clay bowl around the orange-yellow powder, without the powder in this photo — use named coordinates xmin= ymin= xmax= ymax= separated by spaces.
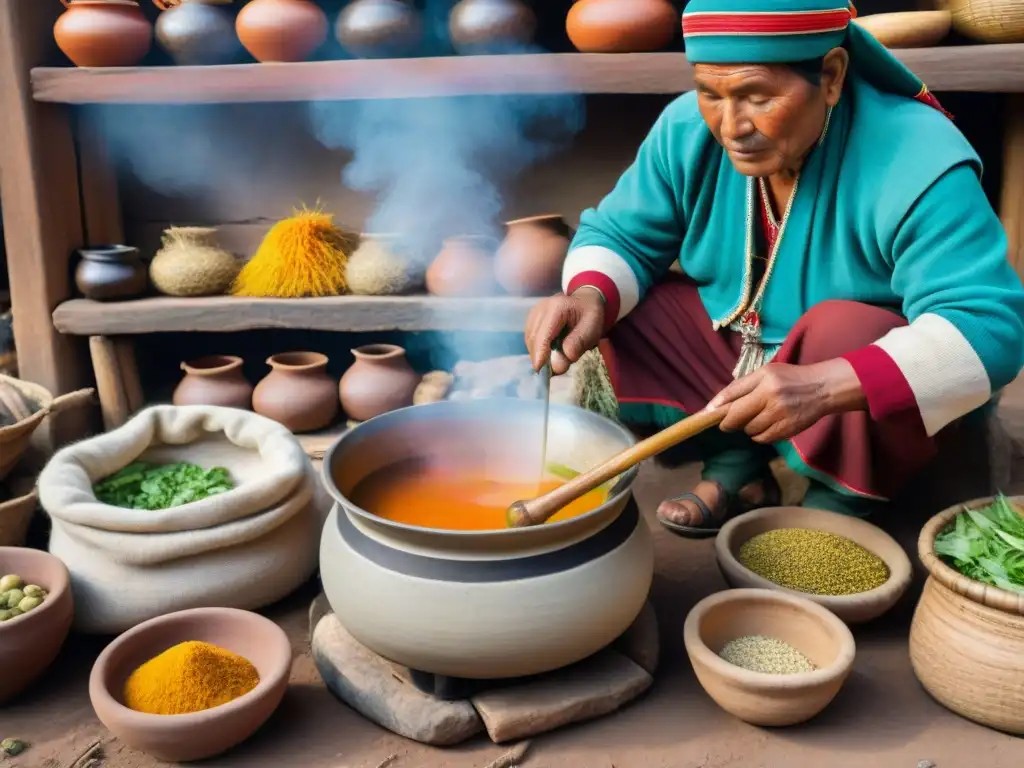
xmin=89 ymin=608 xmax=292 ymax=763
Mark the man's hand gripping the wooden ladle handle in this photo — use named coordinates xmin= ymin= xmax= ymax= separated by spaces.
xmin=708 ymin=358 xmax=866 ymax=443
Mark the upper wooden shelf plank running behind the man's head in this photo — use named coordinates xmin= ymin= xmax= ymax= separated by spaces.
xmin=32 ymin=44 xmax=1024 ymax=104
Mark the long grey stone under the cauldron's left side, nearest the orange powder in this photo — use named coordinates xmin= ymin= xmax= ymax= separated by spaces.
xmin=310 ymin=613 xmax=483 ymax=746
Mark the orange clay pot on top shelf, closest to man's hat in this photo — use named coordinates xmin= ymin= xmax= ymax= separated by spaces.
xmin=565 ymin=0 xmax=680 ymax=53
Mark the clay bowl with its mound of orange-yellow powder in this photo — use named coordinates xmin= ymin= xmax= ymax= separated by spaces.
xmin=89 ymin=608 xmax=292 ymax=763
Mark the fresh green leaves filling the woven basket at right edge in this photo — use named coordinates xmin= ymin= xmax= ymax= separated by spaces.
xmin=935 ymin=494 xmax=1024 ymax=593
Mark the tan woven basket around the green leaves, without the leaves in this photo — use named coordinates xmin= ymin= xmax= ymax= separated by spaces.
xmin=910 ymin=497 xmax=1024 ymax=735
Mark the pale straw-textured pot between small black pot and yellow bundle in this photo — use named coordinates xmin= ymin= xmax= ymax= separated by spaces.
xmin=150 ymin=226 xmax=242 ymax=296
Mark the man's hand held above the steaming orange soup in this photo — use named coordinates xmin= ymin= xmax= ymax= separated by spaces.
xmin=525 ymin=288 xmax=604 ymax=376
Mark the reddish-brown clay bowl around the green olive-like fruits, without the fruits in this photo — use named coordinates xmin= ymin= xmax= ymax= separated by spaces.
xmin=0 ymin=547 xmax=75 ymax=705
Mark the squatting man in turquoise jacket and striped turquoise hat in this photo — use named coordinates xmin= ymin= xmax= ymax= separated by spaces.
xmin=526 ymin=0 xmax=1024 ymax=537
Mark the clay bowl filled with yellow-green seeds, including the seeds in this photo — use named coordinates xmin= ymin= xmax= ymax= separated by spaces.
xmin=715 ymin=507 xmax=912 ymax=624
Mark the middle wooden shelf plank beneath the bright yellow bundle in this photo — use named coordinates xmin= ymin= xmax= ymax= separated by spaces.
xmin=53 ymin=296 xmax=539 ymax=336
